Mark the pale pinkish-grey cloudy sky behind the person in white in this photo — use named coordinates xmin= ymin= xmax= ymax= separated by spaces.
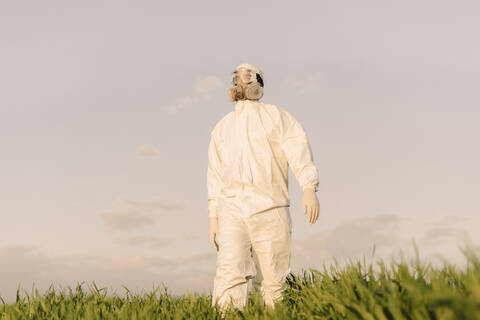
xmin=0 ymin=0 xmax=480 ymax=301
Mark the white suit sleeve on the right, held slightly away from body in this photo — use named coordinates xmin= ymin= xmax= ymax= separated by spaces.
xmin=280 ymin=108 xmax=318 ymax=192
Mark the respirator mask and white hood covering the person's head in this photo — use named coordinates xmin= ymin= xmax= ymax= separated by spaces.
xmin=231 ymin=65 xmax=263 ymax=101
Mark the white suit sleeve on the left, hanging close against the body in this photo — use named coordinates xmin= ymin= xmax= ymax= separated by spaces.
xmin=207 ymin=135 xmax=223 ymax=217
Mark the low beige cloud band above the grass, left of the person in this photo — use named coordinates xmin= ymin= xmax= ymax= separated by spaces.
xmin=0 ymin=244 xmax=215 ymax=303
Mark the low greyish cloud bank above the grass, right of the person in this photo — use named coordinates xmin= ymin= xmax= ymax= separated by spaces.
xmin=292 ymin=214 xmax=478 ymax=272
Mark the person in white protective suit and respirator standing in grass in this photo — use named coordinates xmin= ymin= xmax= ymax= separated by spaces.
xmin=207 ymin=64 xmax=320 ymax=310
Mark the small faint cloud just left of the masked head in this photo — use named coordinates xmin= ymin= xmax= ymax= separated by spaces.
xmin=165 ymin=75 xmax=223 ymax=114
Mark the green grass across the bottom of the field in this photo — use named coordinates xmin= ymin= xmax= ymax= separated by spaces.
xmin=0 ymin=243 xmax=480 ymax=320
